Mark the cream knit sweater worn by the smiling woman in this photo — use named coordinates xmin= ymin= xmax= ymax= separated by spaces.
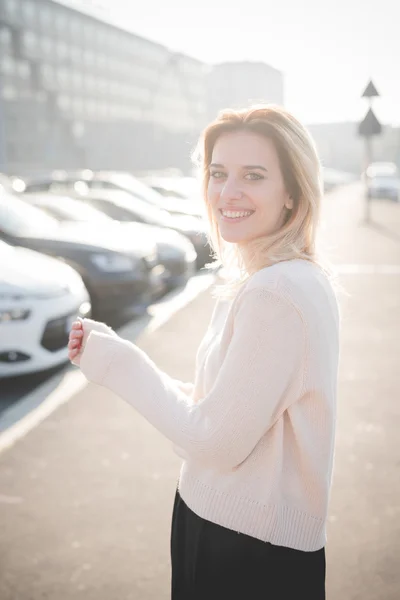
xmin=76 ymin=260 xmax=339 ymax=551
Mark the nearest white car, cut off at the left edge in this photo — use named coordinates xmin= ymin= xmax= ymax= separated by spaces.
xmin=0 ymin=241 xmax=91 ymax=377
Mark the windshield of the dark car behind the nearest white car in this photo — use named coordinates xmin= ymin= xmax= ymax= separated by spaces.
xmin=0 ymin=193 xmax=58 ymax=237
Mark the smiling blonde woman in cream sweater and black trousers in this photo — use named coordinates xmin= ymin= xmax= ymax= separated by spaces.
xmin=69 ymin=106 xmax=339 ymax=600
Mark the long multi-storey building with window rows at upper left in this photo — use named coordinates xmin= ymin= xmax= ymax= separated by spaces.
xmin=0 ymin=0 xmax=206 ymax=171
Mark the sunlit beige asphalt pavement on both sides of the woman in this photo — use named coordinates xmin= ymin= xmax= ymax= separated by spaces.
xmin=0 ymin=185 xmax=400 ymax=600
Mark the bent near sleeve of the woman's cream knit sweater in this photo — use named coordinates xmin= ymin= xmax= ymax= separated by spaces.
xmin=81 ymin=288 xmax=305 ymax=469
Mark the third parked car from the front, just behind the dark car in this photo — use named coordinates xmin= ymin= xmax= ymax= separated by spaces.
xmin=22 ymin=192 xmax=197 ymax=290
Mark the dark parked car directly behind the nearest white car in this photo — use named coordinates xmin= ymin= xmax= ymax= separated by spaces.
xmin=0 ymin=193 xmax=164 ymax=316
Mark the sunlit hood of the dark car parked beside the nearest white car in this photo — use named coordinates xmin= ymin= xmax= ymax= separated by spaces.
xmin=28 ymin=222 xmax=154 ymax=256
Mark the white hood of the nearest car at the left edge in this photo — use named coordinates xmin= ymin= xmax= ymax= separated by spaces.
xmin=0 ymin=245 xmax=83 ymax=301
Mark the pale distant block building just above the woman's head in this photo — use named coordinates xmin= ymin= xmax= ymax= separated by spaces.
xmin=207 ymin=61 xmax=284 ymax=120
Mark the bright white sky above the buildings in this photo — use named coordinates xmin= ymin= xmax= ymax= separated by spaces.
xmin=92 ymin=0 xmax=400 ymax=124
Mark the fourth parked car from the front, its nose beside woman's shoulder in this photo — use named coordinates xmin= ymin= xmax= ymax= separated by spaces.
xmin=41 ymin=190 xmax=211 ymax=269
